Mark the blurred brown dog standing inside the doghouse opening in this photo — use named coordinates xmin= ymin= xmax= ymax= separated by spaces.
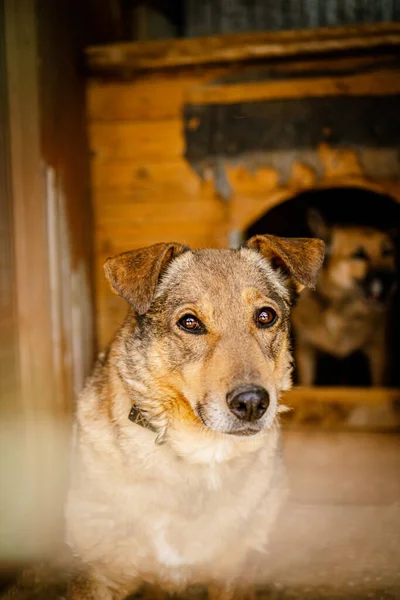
xmin=292 ymin=211 xmax=396 ymax=386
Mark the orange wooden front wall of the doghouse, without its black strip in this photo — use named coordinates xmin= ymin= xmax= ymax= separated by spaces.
xmin=87 ymin=41 xmax=400 ymax=346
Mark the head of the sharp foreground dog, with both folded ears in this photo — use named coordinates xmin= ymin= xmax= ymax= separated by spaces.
xmin=105 ymin=235 xmax=324 ymax=460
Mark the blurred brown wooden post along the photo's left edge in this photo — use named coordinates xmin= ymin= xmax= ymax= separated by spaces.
xmin=0 ymin=0 xmax=93 ymax=562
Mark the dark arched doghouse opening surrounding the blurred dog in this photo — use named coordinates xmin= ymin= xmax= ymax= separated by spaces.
xmin=244 ymin=187 xmax=400 ymax=387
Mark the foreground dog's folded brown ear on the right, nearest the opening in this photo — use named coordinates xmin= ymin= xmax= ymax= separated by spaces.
xmin=245 ymin=235 xmax=325 ymax=292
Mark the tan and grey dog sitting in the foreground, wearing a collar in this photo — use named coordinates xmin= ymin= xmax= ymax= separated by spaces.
xmin=67 ymin=235 xmax=323 ymax=600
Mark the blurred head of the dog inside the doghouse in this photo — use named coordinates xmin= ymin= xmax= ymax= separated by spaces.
xmin=309 ymin=210 xmax=396 ymax=307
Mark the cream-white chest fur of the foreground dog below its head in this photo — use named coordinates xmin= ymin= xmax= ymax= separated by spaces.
xmin=67 ymin=418 xmax=283 ymax=589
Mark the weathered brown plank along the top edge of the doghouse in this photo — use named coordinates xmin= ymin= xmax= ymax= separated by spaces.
xmin=86 ymin=23 xmax=400 ymax=73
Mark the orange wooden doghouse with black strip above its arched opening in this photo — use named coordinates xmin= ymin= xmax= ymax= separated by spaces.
xmin=87 ymin=25 xmax=400 ymax=426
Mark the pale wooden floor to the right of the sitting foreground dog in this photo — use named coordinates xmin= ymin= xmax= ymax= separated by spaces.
xmin=261 ymin=431 xmax=400 ymax=600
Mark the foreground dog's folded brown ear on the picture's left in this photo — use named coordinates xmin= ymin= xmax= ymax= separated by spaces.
xmin=104 ymin=242 xmax=189 ymax=315
